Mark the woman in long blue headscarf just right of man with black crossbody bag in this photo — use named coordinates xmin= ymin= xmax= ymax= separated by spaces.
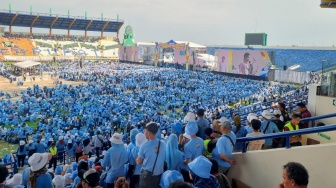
xmin=166 ymin=134 xmax=183 ymax=171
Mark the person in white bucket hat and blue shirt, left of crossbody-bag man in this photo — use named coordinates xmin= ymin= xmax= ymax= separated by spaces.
xmin=102 ymin=133 xmax=128 ymax=187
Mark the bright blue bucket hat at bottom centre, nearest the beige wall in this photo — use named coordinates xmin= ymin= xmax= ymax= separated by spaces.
xmin=188 ymin=156 xmax=212 ymax=178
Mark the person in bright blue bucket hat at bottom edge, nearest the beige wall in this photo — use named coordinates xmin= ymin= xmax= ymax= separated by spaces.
xmin=188 ymin=156 xmax=220 ymax=188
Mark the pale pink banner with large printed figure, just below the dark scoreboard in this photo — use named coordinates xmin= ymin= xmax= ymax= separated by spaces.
xmin=216 ymin=50 xmax=271 ymax=77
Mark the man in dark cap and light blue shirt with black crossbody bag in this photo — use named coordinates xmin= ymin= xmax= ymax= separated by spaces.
xmin=136 ymin=122 xmax=166 ymax=188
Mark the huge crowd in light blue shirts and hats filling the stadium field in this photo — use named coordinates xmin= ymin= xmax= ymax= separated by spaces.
xmin=0 ymin=62 xmax=310 ymax=188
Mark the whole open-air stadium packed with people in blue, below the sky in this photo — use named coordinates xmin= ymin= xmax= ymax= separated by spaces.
xmin=0 ymin=0 xmax=336 ymax=188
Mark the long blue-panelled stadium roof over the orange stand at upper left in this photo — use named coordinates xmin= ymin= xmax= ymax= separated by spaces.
xmin=0 ymin=12 xmax=124 ymax=32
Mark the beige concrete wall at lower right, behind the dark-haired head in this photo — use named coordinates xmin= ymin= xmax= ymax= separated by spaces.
xmin=229 ymin=144 xmax=336 ymax=188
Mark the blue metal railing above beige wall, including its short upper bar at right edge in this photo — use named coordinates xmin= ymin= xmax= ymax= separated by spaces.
xmin=237 ymin=113 xmax=336 ymax=153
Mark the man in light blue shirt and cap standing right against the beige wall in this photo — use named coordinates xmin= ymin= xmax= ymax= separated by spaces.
xmin=212 ymin=121 xmax=236 ymax=175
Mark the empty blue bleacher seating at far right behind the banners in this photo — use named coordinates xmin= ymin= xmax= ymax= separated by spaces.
xmin=207 ymin=46 xmax=336 ymax=72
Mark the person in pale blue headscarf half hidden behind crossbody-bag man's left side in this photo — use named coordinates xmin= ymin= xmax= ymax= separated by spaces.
xmin=130 ymin=133 xmax=147 ymax=188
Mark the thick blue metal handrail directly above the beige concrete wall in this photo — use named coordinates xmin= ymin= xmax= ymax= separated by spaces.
xmin=237 ymin=124 xmax=336 ymax=153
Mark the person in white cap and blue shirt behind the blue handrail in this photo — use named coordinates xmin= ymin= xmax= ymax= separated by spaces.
xmin=260 ymin=110 xmax=279 ymax=149
